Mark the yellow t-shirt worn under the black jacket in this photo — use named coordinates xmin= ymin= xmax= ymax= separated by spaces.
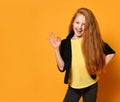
xmin=69 ymin=38 xmax=98 ymax=89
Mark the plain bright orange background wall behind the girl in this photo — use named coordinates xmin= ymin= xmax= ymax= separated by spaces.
xmin=0 ymin=0 xmax=120 ymax=102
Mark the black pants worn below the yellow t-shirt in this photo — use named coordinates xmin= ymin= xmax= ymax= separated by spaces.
xmin=63 ymin=83 xmax=98 ymax=102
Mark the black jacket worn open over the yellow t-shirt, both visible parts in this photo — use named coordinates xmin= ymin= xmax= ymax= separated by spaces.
xmin=60 ymin=37 xmax=115 ymax=84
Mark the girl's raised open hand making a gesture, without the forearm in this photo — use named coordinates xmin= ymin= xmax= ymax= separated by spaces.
xmin=49 ymin=33 xmax=61 ymax=49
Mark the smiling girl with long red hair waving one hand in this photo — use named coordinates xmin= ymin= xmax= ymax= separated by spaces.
xmin=50 ymin=8 xmax=115 ymax=102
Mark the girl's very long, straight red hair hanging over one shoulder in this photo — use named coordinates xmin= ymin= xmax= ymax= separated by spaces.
xmin=69 ymin=8 xmax=105 ymax=74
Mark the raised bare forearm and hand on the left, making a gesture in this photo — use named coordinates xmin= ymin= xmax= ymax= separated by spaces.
xmin=49 ymin=34 xmax=64 ymax=71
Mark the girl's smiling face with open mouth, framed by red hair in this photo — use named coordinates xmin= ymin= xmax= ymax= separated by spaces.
xmin=73 ymin=13 xmax=85 ymax=38
